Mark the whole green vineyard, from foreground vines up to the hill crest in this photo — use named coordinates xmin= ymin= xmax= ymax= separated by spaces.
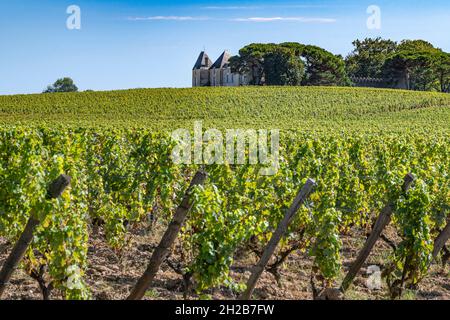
xmin=0 ymin=87 xmax=450 ymax=299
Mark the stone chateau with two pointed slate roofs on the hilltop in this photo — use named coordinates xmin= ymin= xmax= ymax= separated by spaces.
xmin=192 ymin=51 xmax=251 ymax=87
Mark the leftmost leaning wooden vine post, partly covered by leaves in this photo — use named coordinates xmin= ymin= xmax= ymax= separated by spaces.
xmin=0 ymin=175 xmax=71 ymax=298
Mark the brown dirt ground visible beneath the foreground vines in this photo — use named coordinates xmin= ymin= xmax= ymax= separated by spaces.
xmin=0 ymin=222 xmax=450 ymax=300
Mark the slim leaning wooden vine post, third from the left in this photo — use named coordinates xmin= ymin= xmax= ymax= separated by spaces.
xmin=239 ymin=179 xmax=316 ymax=300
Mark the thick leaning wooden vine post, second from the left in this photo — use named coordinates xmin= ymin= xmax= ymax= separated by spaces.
xmin=127 ymin=171 xmax=207 ymax=300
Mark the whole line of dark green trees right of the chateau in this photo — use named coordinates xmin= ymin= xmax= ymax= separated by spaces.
xmin=230 ymin=38 xmax=450 ymax=92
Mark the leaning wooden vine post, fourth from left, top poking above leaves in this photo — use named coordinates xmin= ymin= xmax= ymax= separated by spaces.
xmin=340 ymin=173 xmax=415 ymax=293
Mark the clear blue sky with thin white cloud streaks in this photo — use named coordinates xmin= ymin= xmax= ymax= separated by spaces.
xmin=0 ymin=0 xmax=450 ymax=94
